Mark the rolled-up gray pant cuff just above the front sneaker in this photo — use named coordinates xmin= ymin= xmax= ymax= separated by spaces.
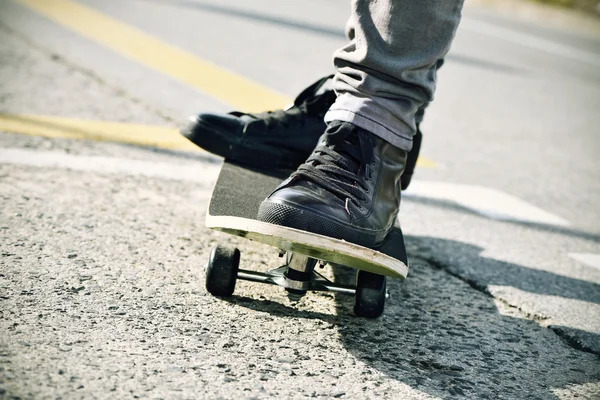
xmin=325 ymin=97 xmax=413 ymax=151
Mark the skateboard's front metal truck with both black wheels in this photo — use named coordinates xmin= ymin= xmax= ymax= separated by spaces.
xmin=206 ymin=245 xmax=389 ymax=318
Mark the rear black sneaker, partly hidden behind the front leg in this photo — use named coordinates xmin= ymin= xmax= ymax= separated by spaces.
xmin=181 ymin=76 xmax=422 ymax=189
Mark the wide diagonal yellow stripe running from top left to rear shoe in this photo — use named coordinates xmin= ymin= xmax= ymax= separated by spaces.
xmin=17 ymin=0 xmax=291 ymax=112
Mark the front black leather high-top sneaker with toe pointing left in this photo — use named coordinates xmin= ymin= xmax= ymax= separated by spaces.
xmin=258 ymin=121 xmax=407 ymax=248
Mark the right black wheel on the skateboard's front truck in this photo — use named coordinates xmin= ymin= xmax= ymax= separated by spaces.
xmin=354 ymin=271 xmax=386 ymax=318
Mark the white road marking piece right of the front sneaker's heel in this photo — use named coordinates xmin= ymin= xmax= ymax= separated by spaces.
xmin=403 ymin=181 xmax=569 ymax=226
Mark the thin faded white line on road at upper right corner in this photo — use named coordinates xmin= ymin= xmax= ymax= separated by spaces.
xmin=460 ymin=18 xmax=600 ymax=67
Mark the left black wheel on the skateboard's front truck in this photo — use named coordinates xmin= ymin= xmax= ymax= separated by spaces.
xmin=206 ymin=246 xmax=240 ymax=297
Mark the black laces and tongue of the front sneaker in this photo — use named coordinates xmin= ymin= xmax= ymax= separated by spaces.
xmin=291 ymin=126 xmax=372 ymax=214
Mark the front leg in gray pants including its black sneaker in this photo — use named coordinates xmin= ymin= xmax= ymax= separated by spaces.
xmin=258 ymin=0 xmax=462 ymax=248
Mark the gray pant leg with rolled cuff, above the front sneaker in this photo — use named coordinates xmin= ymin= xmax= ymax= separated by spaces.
xmin=325 ymin=0 xmax=463 ymax=150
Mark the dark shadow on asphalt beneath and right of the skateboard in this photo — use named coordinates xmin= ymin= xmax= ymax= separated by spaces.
xmin=230 ymin=236 xmax=600 ymax=399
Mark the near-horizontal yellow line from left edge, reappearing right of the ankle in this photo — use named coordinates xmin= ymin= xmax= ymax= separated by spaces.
xmin=0 ymin=113 xmax=436 ymax=168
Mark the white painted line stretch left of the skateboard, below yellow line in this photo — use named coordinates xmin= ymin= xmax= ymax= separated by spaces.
xmin=0 ymin=148 xmax=220 ymax=184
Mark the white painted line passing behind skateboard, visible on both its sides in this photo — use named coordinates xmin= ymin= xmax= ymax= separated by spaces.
xmin=0 ymin=148 xmax=569 ymax=226
